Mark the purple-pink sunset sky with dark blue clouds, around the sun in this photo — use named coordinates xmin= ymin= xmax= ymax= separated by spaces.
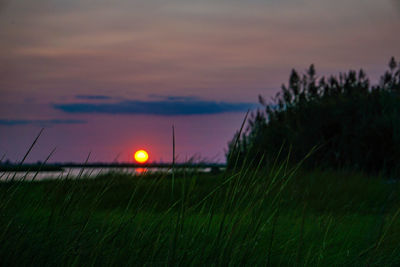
xmin=0 ymin=0 xmax=400 ymax=162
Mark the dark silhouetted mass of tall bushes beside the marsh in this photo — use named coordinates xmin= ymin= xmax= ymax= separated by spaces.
xmin=226 ymin=58 xmax=400 ymax=177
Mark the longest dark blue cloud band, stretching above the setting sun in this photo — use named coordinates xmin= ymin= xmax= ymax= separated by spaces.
xmin=53 ymin=97 xmax=256 ymax=116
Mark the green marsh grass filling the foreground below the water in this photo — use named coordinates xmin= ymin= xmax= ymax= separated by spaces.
xmin=0 ymin=166 xmax=400 ymax=266
